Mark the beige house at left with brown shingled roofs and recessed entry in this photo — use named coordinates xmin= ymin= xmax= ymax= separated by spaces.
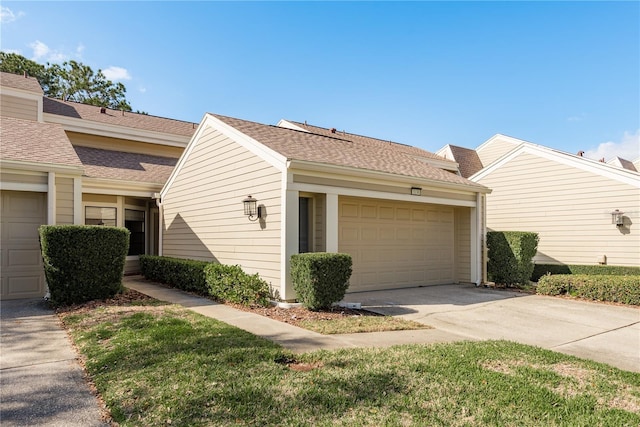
xmin=0 ymin=73 xmax=196 ymax=299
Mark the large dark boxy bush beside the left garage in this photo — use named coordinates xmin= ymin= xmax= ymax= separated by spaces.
xmin=38 ymin=225 xmax=130 ymax=306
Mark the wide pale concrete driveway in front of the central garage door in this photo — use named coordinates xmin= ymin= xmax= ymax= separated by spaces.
xmin=345 ymin=285 xmax=640 ymax=372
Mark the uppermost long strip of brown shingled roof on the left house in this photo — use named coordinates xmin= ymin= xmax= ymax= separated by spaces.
xmin=43 ymin=98 xmax=198 ymax=137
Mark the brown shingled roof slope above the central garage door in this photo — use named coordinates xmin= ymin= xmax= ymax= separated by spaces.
xmin=212 ymin=114 xmax=478 ymax=187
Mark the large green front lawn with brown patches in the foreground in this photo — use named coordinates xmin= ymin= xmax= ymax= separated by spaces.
xmin=62 ymin=305 xmax=640 ymax=426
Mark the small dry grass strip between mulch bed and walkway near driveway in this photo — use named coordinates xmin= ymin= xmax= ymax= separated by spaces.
xmin=298 ymin=316 xmax=431 ymax=335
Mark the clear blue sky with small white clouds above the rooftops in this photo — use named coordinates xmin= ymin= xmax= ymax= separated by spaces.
xmin=0 ymin=1 xmax=640 ymax=160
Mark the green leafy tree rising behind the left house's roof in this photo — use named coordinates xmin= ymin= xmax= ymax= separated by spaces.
xmin=0 ymin=52 xmax=131 ymax=111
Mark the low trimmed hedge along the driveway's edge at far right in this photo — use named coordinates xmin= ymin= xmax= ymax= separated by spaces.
xmin=536 ymin=274 xmax=640 ymax=305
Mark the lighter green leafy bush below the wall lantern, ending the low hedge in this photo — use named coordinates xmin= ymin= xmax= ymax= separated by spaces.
xmin=205 ymin=264 xmax=269 ymax=307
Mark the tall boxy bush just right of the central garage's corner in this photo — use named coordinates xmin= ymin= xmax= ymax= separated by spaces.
xmin=487 ymin=231 xmax=538 ymax=286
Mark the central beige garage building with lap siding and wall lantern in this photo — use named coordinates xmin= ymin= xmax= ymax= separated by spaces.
xmin=160 ymin=114 xmax=490 ymax=300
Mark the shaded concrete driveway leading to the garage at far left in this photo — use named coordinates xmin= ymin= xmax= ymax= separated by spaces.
xmin=0 ymin=299 xmax=109 ymax=427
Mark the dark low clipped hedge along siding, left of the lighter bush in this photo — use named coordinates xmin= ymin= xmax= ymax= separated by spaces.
xmin=140 ymin=255 xmax=210 ymax=295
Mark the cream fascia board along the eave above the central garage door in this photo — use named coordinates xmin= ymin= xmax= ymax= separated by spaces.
xmin=288 ymin=160 xmax=491 ymax=193
